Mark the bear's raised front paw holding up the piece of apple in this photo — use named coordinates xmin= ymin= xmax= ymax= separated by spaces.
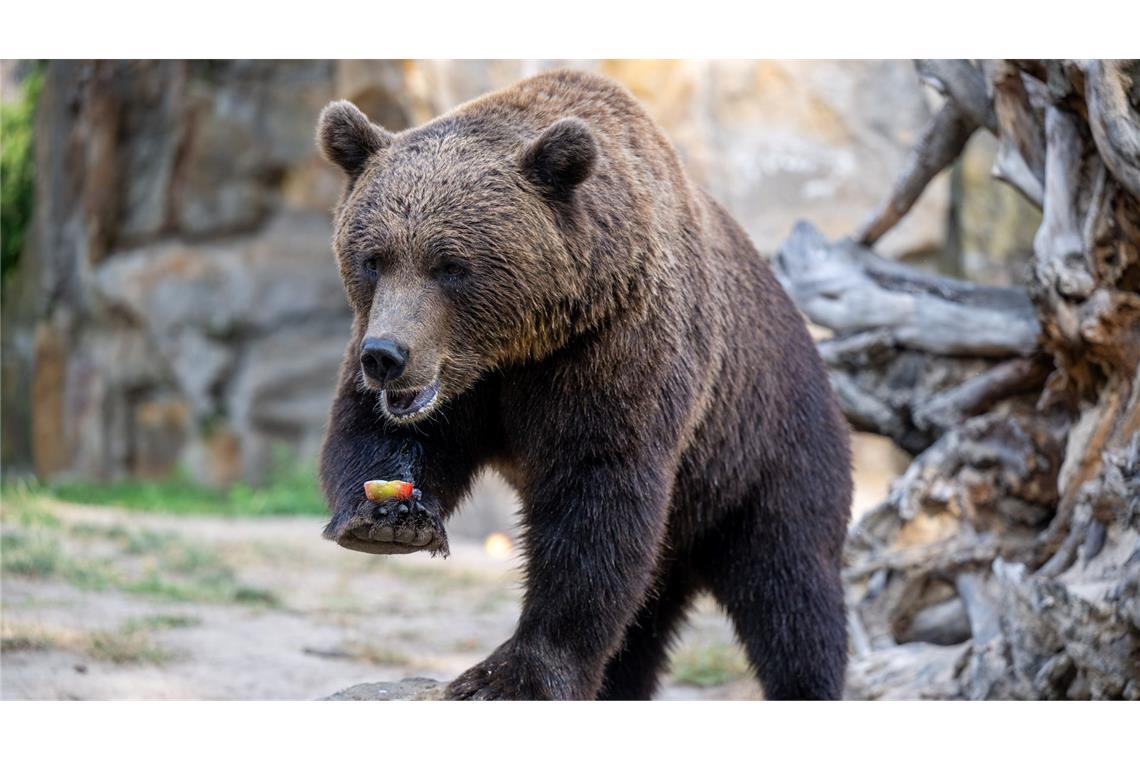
xmin=324 ymin=492 xmax=448 ymax=556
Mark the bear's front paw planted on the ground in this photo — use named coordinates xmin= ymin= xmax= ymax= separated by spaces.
xmin=447 ymin=641 xmax=591 ymax=700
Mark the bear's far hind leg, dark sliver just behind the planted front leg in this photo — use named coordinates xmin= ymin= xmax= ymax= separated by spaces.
xmin=597 ymin=564 xmax=697 ymax=700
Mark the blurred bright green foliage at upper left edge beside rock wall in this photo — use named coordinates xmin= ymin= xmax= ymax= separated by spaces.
xmin=0 ymin=68 xmax=43 ymax=283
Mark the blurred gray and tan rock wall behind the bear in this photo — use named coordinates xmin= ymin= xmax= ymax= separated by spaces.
xmin=2 ymin=62 xmax=950 ymax=483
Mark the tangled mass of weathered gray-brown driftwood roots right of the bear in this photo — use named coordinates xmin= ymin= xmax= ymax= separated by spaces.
xmin=776 ymin=60 xmax=1140 ymax=698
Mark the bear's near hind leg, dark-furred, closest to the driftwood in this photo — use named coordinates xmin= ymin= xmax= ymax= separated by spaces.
xmin=701 ymin=510 xmax=847 ymax=700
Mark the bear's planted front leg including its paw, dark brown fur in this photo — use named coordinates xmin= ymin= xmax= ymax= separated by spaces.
xmin=448 ymin=458 xmax=668 ymax=700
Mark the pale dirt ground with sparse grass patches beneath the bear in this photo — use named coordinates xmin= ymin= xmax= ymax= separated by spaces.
xmin=0 ymin=502 xmax=759 ymax=700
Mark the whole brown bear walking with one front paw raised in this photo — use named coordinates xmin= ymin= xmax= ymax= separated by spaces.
xmin=318 ymin=71 xmax=852 ymax=700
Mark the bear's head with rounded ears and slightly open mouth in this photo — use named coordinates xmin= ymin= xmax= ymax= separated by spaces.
xmin=317 ymin=100 xmax=599 ymax=423
